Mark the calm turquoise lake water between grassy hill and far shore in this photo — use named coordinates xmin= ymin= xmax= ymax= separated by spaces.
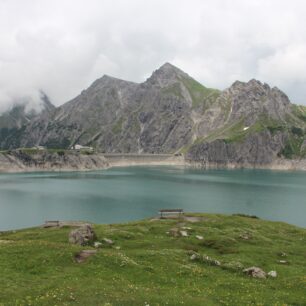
xmin=0 ymin=167 xmax=306 ymax=230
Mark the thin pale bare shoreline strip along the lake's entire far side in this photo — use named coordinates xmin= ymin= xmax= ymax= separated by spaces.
xmin=0 ymin=152 xmax=306 ymax=174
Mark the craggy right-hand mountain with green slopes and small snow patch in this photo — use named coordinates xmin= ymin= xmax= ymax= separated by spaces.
xmin=187 ymin=80 xmax=306 ymax=166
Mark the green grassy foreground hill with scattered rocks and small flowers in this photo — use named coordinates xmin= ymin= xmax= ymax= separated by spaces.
xmin=0 ymin=214 xmax=306 ymax=306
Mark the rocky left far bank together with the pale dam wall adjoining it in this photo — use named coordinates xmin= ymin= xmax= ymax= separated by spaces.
xmin=0 ymin=149 xmax=185 ymax=172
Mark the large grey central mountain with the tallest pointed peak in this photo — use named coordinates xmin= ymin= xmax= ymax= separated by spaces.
xmin=2 ymin=63 xmax=219 ymax=153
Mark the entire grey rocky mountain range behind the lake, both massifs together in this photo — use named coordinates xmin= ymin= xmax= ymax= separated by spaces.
xmin=2 ymin=63 xmax=306 ymax=165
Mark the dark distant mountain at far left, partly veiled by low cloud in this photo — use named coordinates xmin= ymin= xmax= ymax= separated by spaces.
xmin=0 ymin=92 xmax=55 ymax=147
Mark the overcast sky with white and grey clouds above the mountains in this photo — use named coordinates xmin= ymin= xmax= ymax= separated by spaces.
xmin=0 ymin=0 xmax=306 ymax=109
